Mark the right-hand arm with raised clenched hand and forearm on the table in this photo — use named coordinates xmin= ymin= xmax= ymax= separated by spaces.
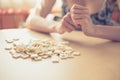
xmin=71 ymin=5 xmax=120 ymax=41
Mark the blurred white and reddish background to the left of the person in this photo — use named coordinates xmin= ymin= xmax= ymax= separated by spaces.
xmin=0 ymin=0 xmax=62 ymax=29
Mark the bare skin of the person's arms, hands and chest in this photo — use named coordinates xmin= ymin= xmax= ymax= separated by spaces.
xmin=26 ymin=0 xmax=120 ymax=41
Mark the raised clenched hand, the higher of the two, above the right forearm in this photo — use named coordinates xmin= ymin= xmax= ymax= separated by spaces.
xmin=70 ymin=4 xmax=94 ymax=35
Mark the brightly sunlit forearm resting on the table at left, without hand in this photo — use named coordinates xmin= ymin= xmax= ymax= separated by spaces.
xmin=27 ymin=15 xmax=57 ymax=33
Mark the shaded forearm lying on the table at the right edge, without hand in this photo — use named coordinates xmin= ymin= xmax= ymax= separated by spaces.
xmin=90 ymin=25 xmax=120 ymax=41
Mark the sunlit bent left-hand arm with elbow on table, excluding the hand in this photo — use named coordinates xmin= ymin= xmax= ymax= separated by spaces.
xmin=26 ymin=0 xmax=59 ymax=33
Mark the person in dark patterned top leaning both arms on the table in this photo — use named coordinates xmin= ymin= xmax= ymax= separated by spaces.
xmin=26 ymin=0 xmax=120 ymax=41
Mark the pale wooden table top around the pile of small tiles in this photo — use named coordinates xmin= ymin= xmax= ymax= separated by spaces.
xmin=0 ymin=29 xmax=120 ymax=80
